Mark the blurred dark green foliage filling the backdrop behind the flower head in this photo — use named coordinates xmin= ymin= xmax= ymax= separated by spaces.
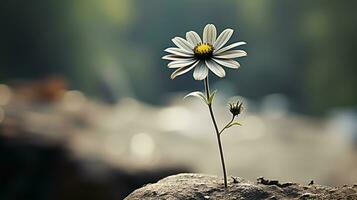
xmin=0 ymin=0 xmax=357 ymax=113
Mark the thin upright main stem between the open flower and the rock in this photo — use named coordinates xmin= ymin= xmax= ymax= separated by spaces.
xmin=204 ymin=76 xmax=228 ymax=188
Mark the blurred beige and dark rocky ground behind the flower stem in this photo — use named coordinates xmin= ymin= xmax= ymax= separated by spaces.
xmin=0 ymin=81 xmax=357 ymax=199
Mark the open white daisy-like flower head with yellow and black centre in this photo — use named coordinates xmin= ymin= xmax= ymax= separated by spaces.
xmin=162 ymin=24 xmax=247 ymax=80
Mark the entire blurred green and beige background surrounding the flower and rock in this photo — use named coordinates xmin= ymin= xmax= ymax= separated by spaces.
xmin=0 ymin=0 xmax=357 ymax=200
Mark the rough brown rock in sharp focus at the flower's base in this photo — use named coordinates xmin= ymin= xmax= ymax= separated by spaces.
xmin=125 ymin=173 xmax=357 ymax=200
